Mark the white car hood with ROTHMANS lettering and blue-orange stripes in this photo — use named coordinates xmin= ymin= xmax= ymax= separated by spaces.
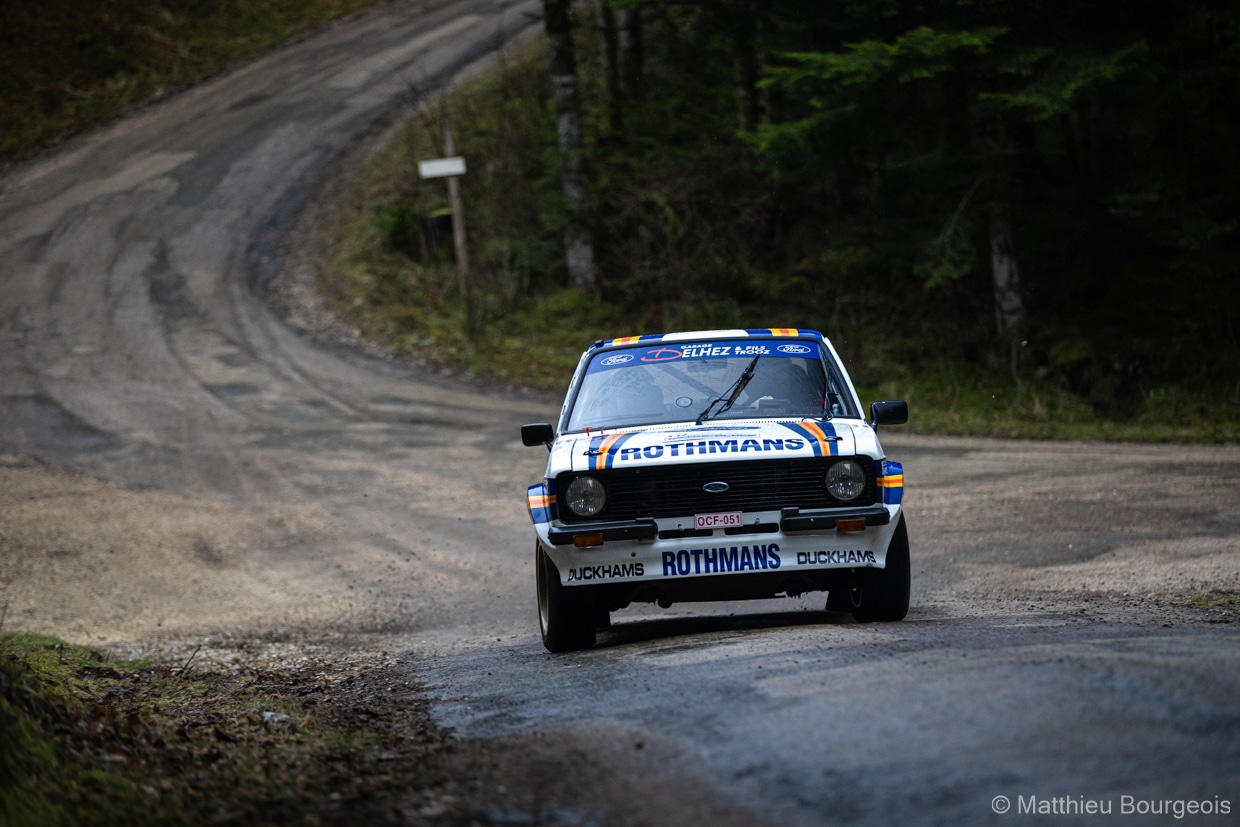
xmin=548 ymin=419 xmax=883 ymax=476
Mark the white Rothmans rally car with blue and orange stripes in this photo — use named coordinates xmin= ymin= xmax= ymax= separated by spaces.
xmin=521 ymin=329 xmax=909 ymax=652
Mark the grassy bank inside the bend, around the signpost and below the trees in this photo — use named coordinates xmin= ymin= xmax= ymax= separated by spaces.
xmin=320 ymin=35 xmax=1240 ymax=443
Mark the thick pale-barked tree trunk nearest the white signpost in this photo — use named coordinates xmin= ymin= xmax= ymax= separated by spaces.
xmin=543 ymin=0 xmax=596 ymax=288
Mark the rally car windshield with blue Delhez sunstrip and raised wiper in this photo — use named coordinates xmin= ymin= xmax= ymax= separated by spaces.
xmin=567 ymin=340 xmax=857 ymax=430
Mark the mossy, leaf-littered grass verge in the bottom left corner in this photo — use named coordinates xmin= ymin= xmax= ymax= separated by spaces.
xmin=0 ymin=634 xmax=456 ymax=827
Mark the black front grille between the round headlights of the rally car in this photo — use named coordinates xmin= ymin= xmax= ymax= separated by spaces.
xmin=556 ymin=456 xmax=878 ymax=522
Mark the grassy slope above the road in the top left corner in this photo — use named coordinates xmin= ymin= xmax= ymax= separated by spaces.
xmin=0 ymin=0 xmax=379 ymax=162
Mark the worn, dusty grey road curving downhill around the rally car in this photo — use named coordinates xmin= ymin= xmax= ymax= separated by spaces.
xmin=0 ymin=1 xmax=1240 ymax=825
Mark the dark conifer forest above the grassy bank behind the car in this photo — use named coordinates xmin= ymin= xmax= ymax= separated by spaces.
xmin=528 ymin=0 xmax=1240 ymax=417
